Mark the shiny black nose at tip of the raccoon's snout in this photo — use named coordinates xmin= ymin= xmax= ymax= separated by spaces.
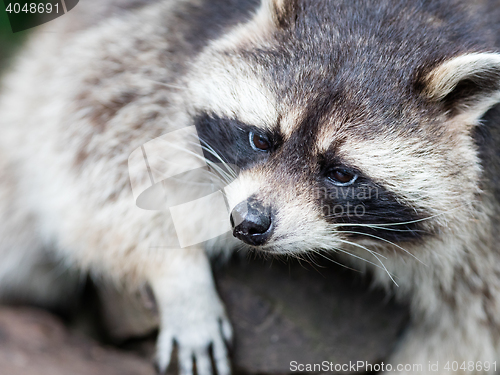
xmin=230 ymin=198 xmax=273 ymax=246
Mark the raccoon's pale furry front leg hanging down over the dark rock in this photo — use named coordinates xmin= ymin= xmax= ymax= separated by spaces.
xmin=150 ymin=248 xmax=232 ymax=375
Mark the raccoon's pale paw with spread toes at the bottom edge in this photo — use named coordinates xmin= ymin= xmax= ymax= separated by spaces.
xmin=156 ymin=305 xmax=233 ymax=375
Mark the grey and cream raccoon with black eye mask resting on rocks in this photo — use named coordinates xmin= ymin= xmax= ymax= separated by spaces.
xmin=0 ymin=0 xmax=500 ymax=375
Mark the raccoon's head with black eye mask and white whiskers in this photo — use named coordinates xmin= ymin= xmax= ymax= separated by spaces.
xmin=186 ymin=0 xmax=500 ymax=254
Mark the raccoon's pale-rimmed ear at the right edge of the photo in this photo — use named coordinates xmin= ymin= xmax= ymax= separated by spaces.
xmin=423 ymin=53 xmax=500 ymax=123
